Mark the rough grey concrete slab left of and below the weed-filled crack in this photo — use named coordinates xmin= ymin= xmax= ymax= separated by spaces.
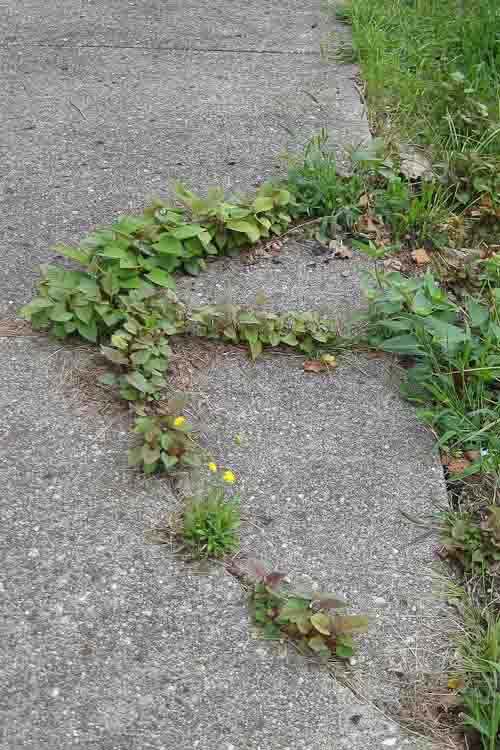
xmin=0 ymin=338 xmax=422 ymax=750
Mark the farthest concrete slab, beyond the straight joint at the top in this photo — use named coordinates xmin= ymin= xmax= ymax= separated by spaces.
xmin=0 ymin=0 xmax=336 ymax=56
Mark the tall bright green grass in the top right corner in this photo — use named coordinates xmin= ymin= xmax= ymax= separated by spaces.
xmin=338 ymin=0 xmax=500 ymax=187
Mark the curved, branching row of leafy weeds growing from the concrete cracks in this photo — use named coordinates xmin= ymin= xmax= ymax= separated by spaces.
xmin=21 ymin=173 xmax=367 ymax=658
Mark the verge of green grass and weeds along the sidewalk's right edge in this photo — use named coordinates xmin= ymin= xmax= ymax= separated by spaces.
xmin=336 ymin=0 xmax=500 ymax=750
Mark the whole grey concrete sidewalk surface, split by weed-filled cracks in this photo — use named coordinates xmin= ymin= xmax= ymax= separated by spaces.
xmin=0 ymin=0 xmax=444 ymax=750
